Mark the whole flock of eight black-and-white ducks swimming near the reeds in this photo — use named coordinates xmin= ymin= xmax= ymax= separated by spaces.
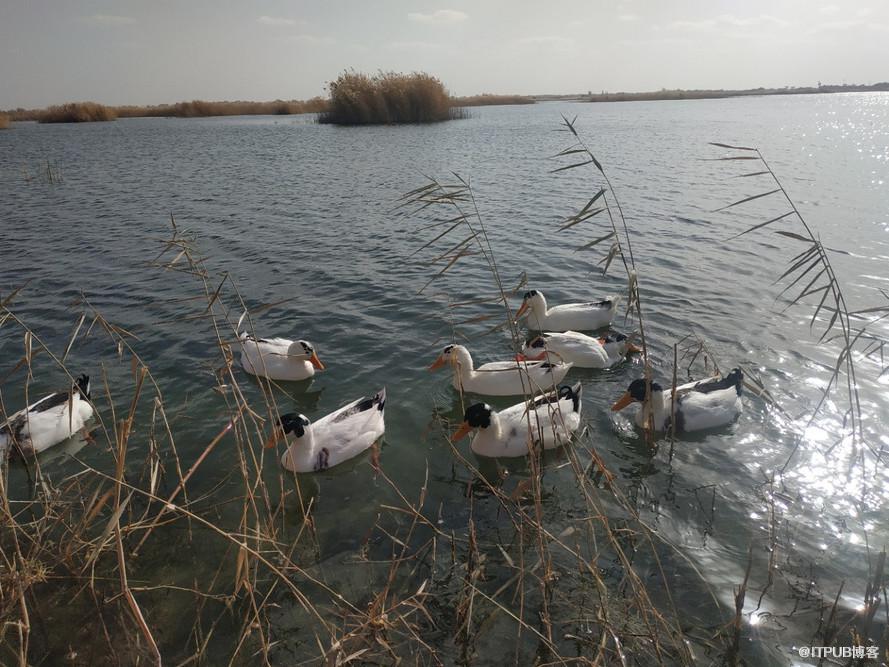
xmin=0 ymin=290 xmax=743 ymax=473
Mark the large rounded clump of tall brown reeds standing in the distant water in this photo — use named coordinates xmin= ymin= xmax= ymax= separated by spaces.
xmin=318 ymin=72 xmax=462 ymax=125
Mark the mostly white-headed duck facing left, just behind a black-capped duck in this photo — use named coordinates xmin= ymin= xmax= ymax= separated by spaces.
xmin=429 ymin=345 xmax=572 ymax=396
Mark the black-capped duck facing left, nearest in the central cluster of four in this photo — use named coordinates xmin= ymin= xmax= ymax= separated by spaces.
xmin=451 ymin=382 xmax=581 ymax=458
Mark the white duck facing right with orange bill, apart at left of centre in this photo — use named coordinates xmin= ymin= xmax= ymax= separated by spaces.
xmin=239 ymin=332 xmax=324 ymax=381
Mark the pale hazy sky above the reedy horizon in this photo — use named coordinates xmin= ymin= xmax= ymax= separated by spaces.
xmin=0 ymin=0 xmax=889 ymax=108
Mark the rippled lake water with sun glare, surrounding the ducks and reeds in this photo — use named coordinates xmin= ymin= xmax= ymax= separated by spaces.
xmin=0 ymin=94 xmax=889 ymax=665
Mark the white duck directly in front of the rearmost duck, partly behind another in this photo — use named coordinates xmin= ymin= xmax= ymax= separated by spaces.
xmin=517 ymin=331 xmax=642 ymax=368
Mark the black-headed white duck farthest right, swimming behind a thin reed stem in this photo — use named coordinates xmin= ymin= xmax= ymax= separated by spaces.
xmin=611 ymin=368 xmax=744 ymax=433
